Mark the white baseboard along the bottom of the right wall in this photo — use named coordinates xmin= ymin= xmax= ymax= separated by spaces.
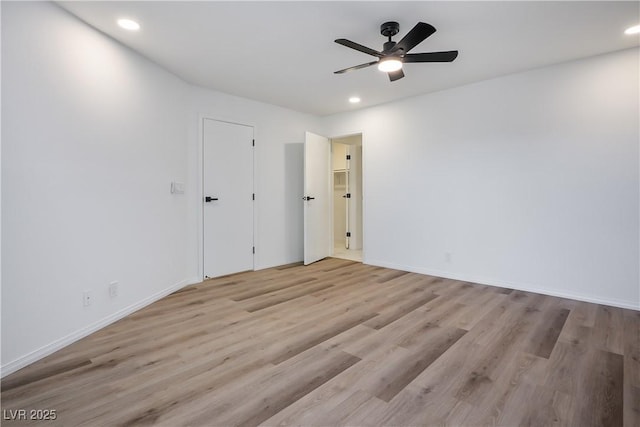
xmin=366 ymin=260 xmax=640 ymax=311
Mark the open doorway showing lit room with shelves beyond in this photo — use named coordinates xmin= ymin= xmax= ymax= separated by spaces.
xmin=331 ymin=134 xmax=363 ymax=262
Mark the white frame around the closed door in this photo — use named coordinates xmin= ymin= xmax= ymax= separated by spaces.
xmin=195 ymin=113 xmax=259 ymax=281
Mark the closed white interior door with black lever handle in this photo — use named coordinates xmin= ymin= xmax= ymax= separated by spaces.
xmin=202 ymin=119 xmax=254 ymax=277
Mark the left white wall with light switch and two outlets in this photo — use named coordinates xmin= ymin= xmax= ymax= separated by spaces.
xmin=2 ymin=2 xmax=189 ymax=375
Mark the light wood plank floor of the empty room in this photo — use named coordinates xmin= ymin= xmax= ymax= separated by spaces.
xmin=1 ymin=259 xmax=640 ymax=427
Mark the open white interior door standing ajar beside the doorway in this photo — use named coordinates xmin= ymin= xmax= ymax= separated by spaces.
xmin=303 ymin=132 xmax=333 ymax=265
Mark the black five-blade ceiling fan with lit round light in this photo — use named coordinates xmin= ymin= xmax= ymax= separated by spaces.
xmin=334 ymin=21 xmax=458 ymax=82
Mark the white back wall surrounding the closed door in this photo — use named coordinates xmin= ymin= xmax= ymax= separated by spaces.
xmin=188 ymin=87 xmax=319 ymax=279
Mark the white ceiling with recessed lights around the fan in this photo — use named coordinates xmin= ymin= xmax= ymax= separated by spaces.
xmin=58 ymin=1 xmax=640 ymax=115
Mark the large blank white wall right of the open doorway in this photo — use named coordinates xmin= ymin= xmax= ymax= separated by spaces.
xmin=324 ymin=49 xmax=640 ymax=309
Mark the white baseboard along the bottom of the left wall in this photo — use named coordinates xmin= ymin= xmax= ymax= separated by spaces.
xmin=0 ymin=278 xmax=195 ymax=378
